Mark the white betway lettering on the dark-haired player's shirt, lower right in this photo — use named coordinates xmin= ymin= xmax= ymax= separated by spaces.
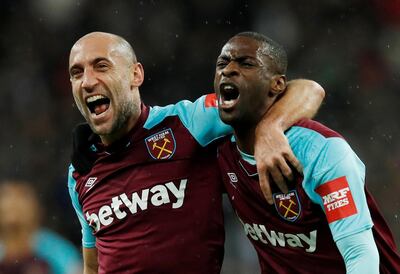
xmin=239 ymin=219 xmax=317 ymax=253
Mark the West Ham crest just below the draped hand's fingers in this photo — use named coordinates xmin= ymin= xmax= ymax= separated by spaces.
xmin=273 ymin=190 xmax=301 ymax=222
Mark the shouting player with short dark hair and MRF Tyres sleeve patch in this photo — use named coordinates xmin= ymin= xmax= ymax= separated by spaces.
xmin=214 ymin=32 xmax=400 ymax=273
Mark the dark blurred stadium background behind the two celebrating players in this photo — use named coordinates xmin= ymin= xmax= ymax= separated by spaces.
xmin=0 ymin=0 xmax=400 ymax=273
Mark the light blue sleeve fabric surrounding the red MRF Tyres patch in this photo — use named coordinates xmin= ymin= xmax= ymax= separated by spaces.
xmin=287 ymin=127 xmax=373 ymax=241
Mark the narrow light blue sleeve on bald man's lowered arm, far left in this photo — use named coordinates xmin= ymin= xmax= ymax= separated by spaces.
xmin=68 ymin=165 xmax=96 ymax=248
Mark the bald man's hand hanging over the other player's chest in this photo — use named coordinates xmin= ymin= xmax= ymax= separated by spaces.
xmin=254 ymin=126 xmax=302 ymax=204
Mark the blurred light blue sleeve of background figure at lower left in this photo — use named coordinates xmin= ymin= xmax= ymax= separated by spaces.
xmin=34 ymin=229 xmax=82 ymax=274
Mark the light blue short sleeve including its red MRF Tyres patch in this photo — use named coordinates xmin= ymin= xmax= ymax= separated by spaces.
xmin=310 ymin=138 xmax=373 ymax=241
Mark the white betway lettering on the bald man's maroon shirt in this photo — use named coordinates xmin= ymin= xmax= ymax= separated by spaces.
xmin=85 ymin=179 xmax=187 ymax=231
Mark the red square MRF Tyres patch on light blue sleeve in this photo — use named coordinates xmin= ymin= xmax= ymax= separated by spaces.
xmin=315 ymin=176 xmax=357 ymax=223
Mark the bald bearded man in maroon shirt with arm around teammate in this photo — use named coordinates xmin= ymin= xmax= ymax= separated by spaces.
xmin=68 ymin=32 xmax=324 ymax=274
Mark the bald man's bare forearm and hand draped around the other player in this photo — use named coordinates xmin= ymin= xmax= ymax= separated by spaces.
xmin=254 ymin=79 xmax=325 ymax=204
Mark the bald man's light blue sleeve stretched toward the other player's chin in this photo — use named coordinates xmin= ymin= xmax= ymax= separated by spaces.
xmin=144 ymin=93 xmax=233 ymax=146
